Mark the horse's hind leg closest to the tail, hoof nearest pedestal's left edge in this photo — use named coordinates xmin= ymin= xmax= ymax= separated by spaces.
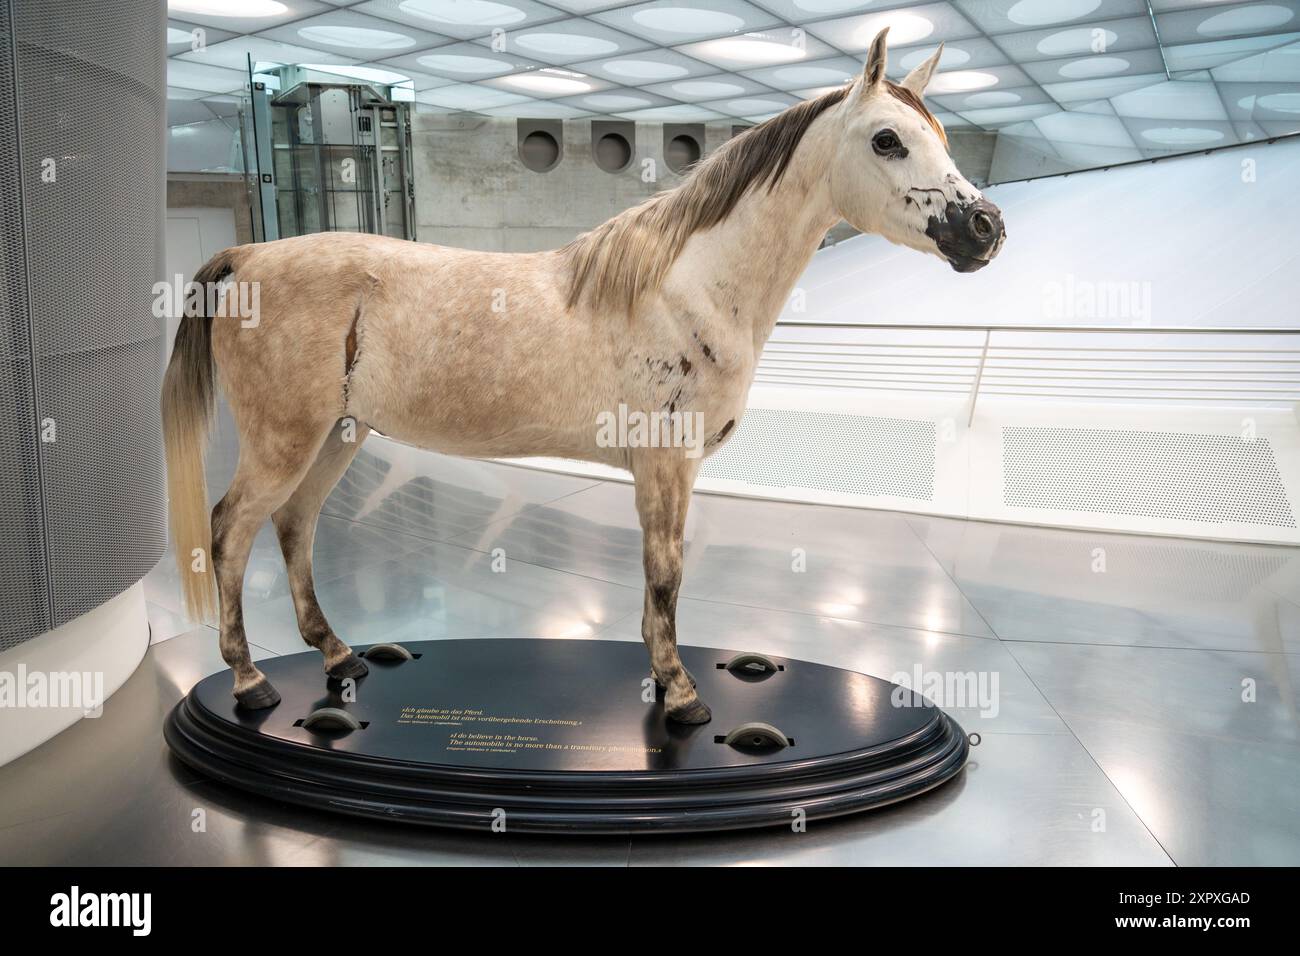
xmin=212 ymin=423 xmax=338 ymax=710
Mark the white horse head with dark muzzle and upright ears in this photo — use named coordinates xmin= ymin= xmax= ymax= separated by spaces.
xmin=831 ymin=27 xmax=1006 ymax=272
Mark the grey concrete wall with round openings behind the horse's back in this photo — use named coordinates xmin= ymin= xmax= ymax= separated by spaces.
xmin=411 ymin=112 xmax=995 ymax=252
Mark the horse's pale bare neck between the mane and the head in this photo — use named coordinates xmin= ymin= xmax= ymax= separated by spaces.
xmin=696 ymin=109 xmax=840 ymax=355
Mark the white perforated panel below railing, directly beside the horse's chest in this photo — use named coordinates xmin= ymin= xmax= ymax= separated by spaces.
xmin=699 ymin=408 xmax=937 ymax=501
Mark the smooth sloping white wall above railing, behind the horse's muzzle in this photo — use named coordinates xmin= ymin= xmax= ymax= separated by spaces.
xmin=781 ymin=139 xmax=1300 ymax=328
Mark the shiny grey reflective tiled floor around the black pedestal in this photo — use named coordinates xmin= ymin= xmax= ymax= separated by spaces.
xmin=0 ymin=429 xmax=1300 ymax=866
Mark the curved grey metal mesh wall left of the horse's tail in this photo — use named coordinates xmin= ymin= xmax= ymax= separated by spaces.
xmin=0 ymin=0 xmax=166 ymax=650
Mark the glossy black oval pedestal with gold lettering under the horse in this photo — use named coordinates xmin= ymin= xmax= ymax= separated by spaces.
xmin=165 ymin=639 xmax=967 ymax=834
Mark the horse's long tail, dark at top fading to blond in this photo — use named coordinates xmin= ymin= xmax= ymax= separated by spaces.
xmin=163 ymin=248 xmax=239 ymax=622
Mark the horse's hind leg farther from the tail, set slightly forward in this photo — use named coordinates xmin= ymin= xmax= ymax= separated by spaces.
xmin=270 ymin=420 xmax=371 ymax=678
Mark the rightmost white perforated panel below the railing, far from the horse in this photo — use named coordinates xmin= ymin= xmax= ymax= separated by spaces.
xmin=1002 ymin=425 xmax=1296 ymax=528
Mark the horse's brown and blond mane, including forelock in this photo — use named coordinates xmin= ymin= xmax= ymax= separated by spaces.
xmin=559 ymin=81 xmax=948 ymax=312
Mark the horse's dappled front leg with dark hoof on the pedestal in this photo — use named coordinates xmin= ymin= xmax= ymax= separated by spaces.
xmin=632 ymin=449 xmax=711 ymax=723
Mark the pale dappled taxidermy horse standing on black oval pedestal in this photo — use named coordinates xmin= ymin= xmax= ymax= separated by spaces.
xmin=163 ymin=33 xmax=1004 ymax=723
